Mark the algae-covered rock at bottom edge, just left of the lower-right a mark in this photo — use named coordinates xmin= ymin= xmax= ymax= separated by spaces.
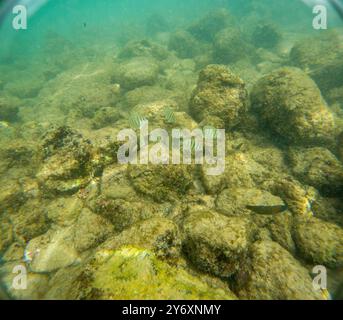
xmin=237 ymin=241 xmax=323 ymax=300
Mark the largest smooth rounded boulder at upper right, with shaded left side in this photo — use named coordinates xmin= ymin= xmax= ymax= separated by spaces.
xmin=251 ymin=68 xmax=335 ymax=145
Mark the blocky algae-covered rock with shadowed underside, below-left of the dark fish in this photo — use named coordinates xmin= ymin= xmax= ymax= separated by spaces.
xmin=183 ymin=212 xmax=253 ymax=278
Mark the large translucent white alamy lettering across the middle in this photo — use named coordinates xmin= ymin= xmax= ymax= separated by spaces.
xmin=117 ymin=120 xmax=225 ymax=176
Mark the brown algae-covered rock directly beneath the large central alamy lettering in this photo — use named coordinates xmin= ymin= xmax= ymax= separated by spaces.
xmin=128 ymin=165 xmax=193 ymax=202
